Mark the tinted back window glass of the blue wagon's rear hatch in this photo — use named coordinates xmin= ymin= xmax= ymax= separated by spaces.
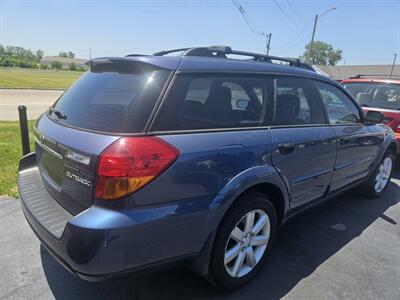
xmin=48 ymin=68 xmax=170 ymax=133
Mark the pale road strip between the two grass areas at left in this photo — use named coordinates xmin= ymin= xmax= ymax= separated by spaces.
xmin=0 ymin=89 xmax=64 ymax=121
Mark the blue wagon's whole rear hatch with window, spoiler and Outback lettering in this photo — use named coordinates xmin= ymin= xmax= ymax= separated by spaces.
xmin=34 ymin=59 xmax=171 ymax=215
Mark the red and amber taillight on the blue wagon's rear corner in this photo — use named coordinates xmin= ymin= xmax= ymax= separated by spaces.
xmin=95 ymin=137 xmax=179 ymax=199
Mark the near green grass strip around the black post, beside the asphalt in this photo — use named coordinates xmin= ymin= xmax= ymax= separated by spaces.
xmin=0 ymin=120 xmax=34 ymax=197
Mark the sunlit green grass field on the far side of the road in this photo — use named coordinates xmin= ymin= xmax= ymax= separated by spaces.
xmin=0 ymin=68 xmax=82 ymax=89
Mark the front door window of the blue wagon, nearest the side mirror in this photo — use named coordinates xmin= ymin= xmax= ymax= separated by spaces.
xmin=315 ymin=81 xmax=361 ymax=125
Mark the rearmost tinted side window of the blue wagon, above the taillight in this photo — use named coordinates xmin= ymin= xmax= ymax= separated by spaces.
xmin=153 ymin=75 xmax=272 ymax=131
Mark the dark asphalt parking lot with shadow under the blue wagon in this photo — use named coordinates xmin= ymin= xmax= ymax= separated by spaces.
xmin=0 ymin=171 xmax=400 ymax=300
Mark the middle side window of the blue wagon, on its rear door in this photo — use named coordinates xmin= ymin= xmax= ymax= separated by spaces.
xmin=274 ymin=76 xmax=326 ymax=126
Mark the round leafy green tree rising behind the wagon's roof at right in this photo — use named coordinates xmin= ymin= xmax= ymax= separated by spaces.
xmin=302 ymin=41 xmax=342 ymax=66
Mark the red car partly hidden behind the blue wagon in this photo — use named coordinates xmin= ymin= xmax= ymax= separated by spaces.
xmin=341 ymin=75 xmax=400 ymax=154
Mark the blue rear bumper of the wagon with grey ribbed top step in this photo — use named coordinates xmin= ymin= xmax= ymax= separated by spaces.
xmin=18 ymin=154 xmax=214 ymax=281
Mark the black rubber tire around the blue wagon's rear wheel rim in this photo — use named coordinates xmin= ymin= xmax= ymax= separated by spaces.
xmin=211 ymin=192 xmax=277 ymax=289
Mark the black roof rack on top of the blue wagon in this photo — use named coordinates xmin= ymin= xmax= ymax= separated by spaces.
xmin=153 ymin=46 xmax=315 ymax=71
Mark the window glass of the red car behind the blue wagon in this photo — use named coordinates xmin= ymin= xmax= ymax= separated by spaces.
xmin=343 ymin=82 xmax=400 ymax=110
